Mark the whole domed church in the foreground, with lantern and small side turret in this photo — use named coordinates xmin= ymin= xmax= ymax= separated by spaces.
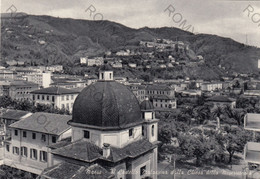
xmin=41 ymin=67 xmax=158 ymax=179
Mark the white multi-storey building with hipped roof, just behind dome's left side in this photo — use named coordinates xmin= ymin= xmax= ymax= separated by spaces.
xmin=31 ymin=87 xmax=79 ymax=112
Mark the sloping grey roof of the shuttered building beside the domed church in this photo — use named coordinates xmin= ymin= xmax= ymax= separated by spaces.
xmin=10 ymin=112 xmax=72 ymax=135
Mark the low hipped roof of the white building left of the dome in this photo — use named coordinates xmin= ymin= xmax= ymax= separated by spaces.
xmin=31 ymin=87 xmax=79 ymax=95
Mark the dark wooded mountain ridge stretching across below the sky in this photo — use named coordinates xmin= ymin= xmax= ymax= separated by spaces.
xmin=1 ymin=14 xmax=260 ymax=77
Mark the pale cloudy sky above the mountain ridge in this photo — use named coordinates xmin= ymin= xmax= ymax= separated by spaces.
xmin=1 ymin=0 xmax=260 ymax=47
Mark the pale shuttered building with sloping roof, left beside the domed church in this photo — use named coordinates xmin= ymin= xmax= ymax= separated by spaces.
xmin=4 ymin=113 xmax=71 ymax=175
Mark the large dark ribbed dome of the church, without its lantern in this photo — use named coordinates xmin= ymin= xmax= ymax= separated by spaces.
xmin=70 ymin=81 xmax=143 ymax=130
